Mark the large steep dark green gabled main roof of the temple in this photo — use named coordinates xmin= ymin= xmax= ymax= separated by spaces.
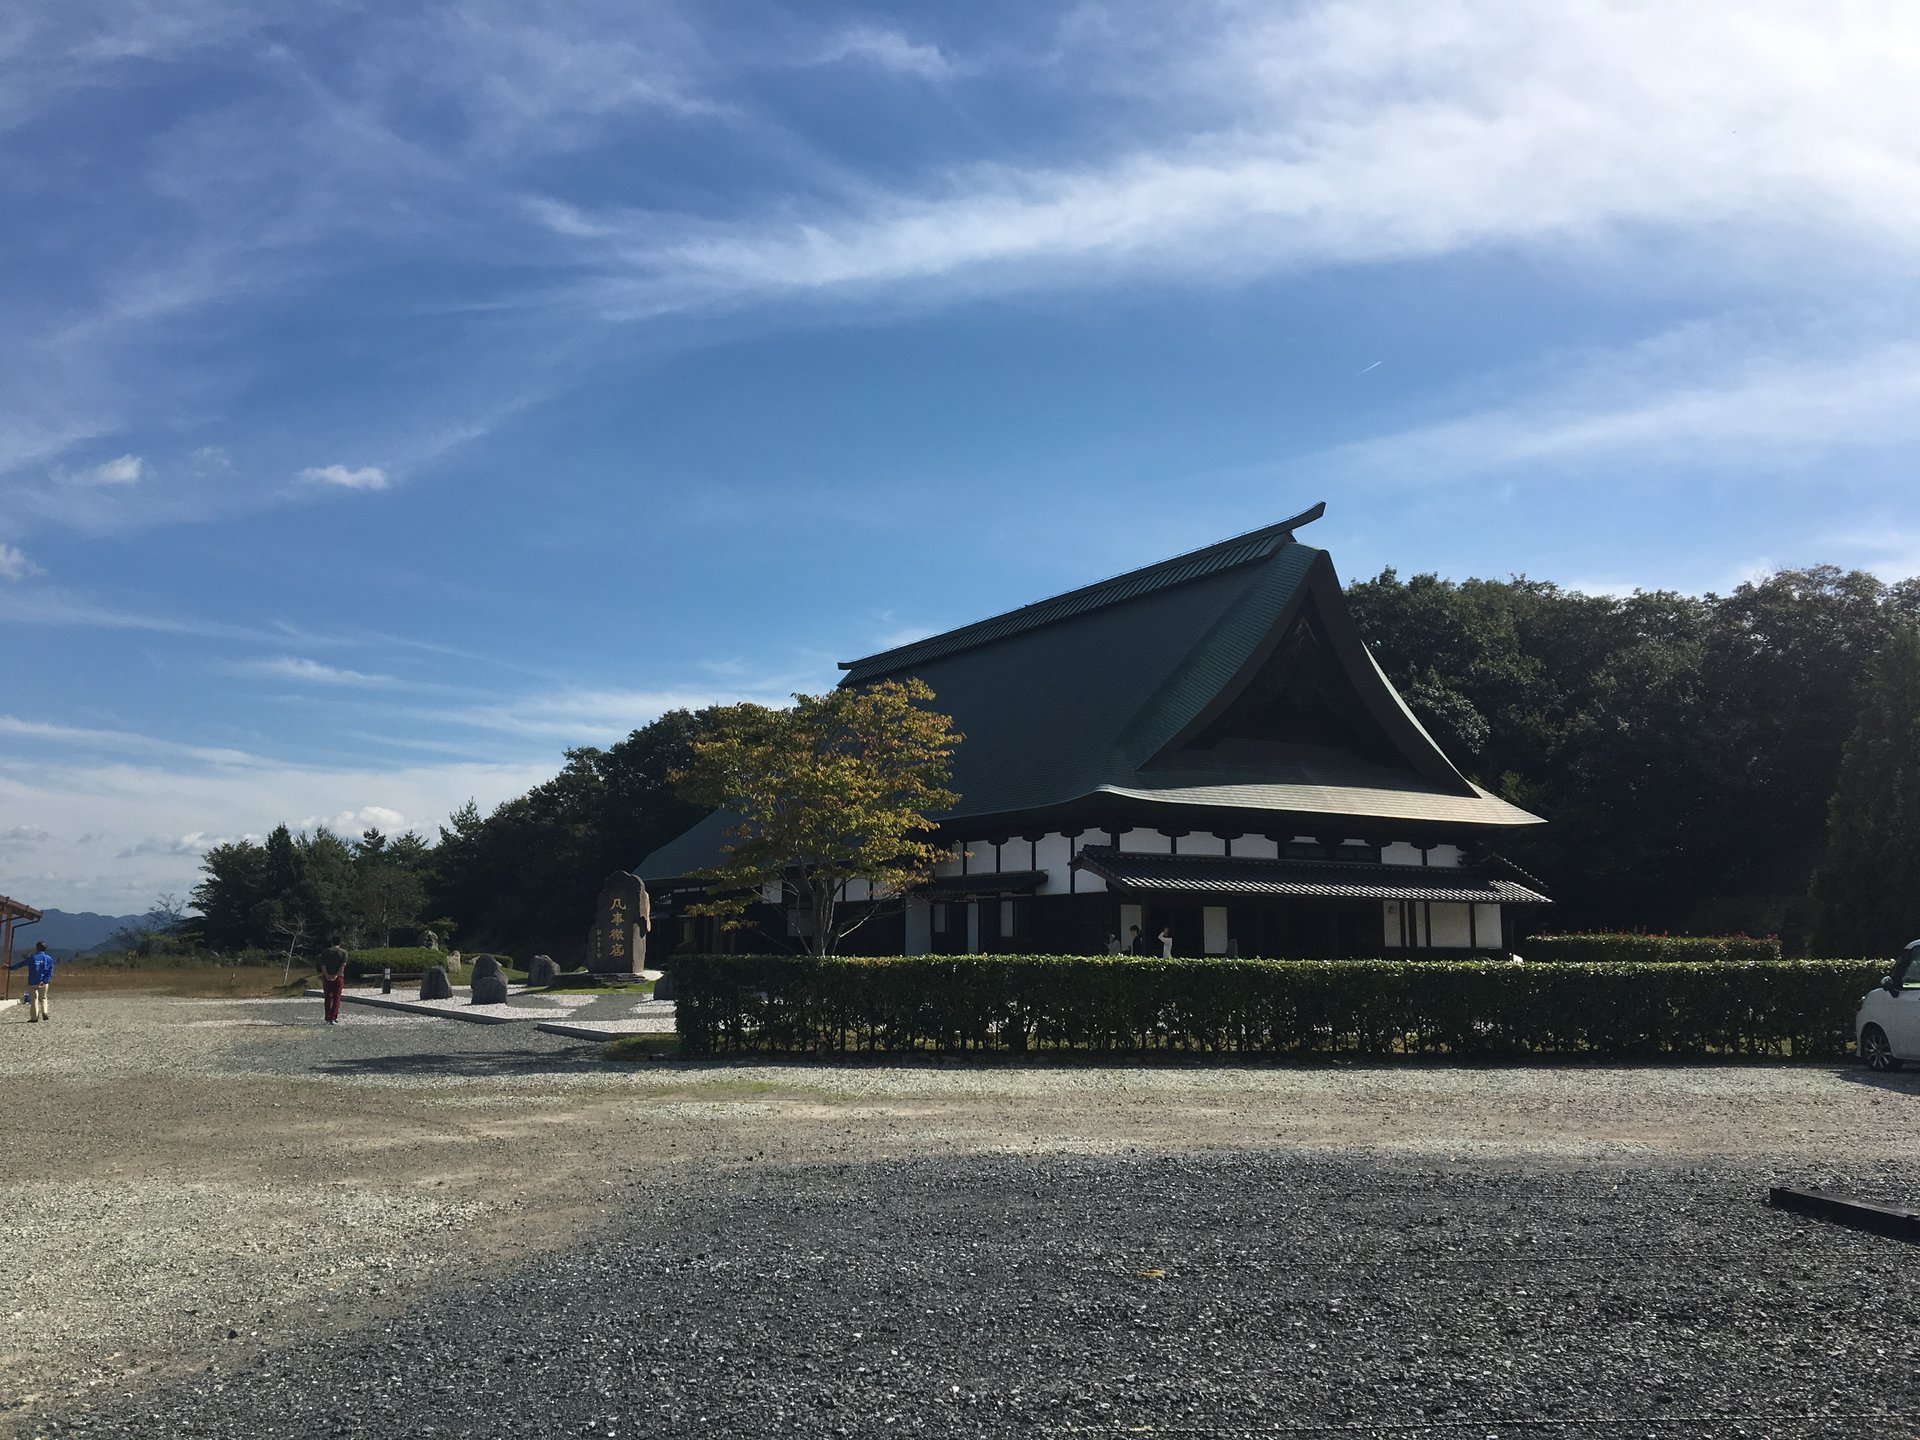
xmin=639 ymin=505 xmax=1538 ymax=877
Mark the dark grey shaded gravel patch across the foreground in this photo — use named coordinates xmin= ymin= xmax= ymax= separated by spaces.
xmin=45 ymin=1154 xmax=1920 ymax=1440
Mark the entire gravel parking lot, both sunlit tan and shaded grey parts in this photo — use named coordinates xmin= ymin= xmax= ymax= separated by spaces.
xmin=0 ymin=996 xmax=1920 ymax=1436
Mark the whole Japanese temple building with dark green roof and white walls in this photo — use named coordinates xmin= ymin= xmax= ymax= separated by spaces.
xmin=637 ymin=505 xmax=1548 ymax=958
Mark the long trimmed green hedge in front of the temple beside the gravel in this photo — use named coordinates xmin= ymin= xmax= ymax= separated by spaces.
xmin=674 ymin=954 xmax=1884 ymax=1058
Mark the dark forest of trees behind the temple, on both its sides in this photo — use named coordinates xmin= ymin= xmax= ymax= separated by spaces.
xmin=192 ymin=566 xmax=1920 ymax=956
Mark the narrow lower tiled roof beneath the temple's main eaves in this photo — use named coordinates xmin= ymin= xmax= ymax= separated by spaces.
xmin=1073 ymin=845 xmax=1548 ymax=904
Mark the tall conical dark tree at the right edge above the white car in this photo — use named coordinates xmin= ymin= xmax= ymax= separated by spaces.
xmin=1812 ymin=626 xmax=1920 ymax=956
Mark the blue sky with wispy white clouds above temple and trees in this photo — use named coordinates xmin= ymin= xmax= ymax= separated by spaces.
xmin=0 ymin=0 xmax=1920 ymax=914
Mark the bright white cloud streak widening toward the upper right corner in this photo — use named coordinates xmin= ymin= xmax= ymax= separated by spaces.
xmin=568 ymin=0 xmax=1920 ymax=315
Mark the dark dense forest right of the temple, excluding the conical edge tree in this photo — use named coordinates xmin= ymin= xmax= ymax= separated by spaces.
xmin=1348 ymin=566 xmax=1920 ymax=950
